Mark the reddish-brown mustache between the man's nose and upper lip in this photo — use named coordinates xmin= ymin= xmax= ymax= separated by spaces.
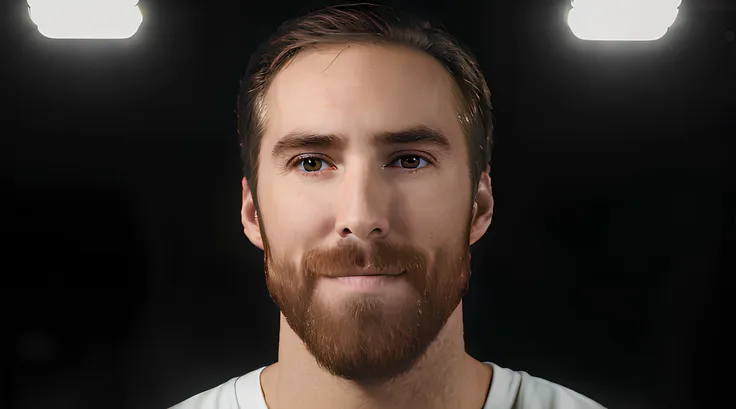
xmin=302 ymin=241 xmax=427 ymax=277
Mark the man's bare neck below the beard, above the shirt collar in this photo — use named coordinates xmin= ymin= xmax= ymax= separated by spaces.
xmin=261 ymin=303 xmax=492 ymax=409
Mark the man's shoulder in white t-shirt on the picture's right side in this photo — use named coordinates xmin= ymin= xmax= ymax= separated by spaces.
xmin=486 ymin=364 xmax=605 ymax=409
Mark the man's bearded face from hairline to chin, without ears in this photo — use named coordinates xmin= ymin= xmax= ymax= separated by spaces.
xmin=247 ymin=45 xmax=480 ymax=384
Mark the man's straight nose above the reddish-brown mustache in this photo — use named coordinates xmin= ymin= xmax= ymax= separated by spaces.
xmin=335 ymin=163 xmax=390 ymax=240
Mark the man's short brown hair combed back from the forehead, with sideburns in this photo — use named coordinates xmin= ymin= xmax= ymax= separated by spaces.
xmin=237 ymin=3 xmax=493 ymax=212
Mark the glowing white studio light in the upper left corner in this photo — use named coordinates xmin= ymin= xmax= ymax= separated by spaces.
xmin=28 ymin=0 xmax=143 ymax=39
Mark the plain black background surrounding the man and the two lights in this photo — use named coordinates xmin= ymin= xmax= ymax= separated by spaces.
xmin=0 ymin=0 xmax=736 ymax=409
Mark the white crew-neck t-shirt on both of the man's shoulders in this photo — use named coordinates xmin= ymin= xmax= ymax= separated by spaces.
xmin=170 ymin=362 xmax=605 ymax=409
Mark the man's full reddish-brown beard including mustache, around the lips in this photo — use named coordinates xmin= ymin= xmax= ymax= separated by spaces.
xmin=261 ymin=209 xmax=470 ymax=386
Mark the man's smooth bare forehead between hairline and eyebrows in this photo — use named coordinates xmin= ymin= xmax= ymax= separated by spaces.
xmin=264 ymin=45 xmax=461 ymax=151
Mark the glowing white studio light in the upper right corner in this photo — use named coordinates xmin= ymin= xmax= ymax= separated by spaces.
xmin=567 ymin=0 xmax=682 ymax=41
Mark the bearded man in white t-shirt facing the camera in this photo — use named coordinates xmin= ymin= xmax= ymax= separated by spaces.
xmin=175 ymin=4 xmax=601 ymax=409
